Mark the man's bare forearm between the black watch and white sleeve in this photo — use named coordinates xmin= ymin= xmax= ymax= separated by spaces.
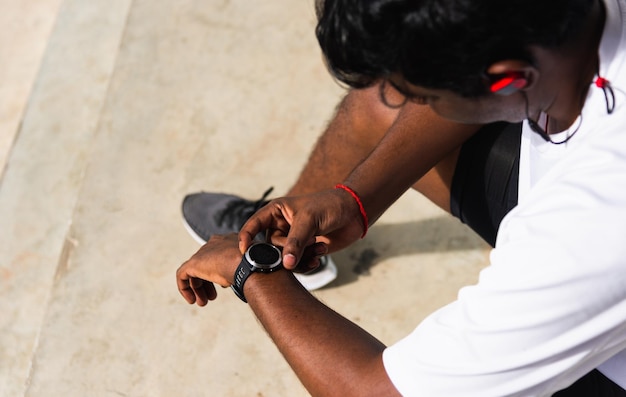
xmin=244 ymin=271 xmax=399 ymax=396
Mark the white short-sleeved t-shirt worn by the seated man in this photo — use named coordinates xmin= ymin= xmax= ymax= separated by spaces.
xmin=383 ymin=0 xmax=626 ymax=397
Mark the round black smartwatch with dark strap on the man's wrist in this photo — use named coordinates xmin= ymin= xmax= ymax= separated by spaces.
xmin=231 ymin=243 xmax=283 ymax=303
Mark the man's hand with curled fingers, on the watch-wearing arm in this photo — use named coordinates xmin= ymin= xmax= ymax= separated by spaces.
xmin=176 ymin=233 xmax=242 ymax=306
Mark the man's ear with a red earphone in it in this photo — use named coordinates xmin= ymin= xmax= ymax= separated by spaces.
xmin=487 ymin=60 xmax=534 ymax=95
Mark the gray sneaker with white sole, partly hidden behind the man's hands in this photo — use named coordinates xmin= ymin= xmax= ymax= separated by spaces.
xmin=182 ymin=187 xmax=337 ymax=291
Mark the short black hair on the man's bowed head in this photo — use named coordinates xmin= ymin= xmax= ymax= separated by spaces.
xmin=316 ymin=0 xmax=597 ymax=97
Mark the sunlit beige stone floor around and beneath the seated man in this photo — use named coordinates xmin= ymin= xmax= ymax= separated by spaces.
xmin=0 ymin=0 xmax=487 ymax=397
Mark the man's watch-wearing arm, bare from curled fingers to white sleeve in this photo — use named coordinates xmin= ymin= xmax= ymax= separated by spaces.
xmin=176 ymin=235 xmax=399 ymax=397
